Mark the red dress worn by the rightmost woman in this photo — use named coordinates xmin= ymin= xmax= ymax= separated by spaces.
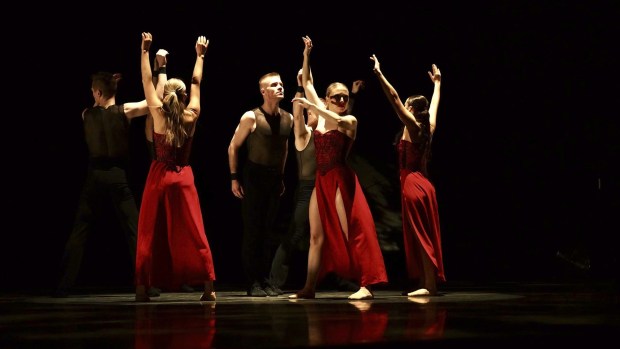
xmin=398 ymin=139 xmax=446 ymax=281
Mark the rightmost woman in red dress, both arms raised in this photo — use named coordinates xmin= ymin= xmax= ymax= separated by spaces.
xmin=370 ymin=55 xmax=446 ymax=297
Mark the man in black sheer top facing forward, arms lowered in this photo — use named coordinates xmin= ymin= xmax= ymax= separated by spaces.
xmin=228 ymin=72 xmax=293 ymax=297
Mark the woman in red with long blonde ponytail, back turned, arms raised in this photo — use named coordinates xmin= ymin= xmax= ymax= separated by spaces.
xmin=136 ymin=33 xmax=215 ymax=302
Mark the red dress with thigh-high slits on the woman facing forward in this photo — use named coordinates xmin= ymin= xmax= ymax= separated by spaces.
xmin=314 ymin=130 xmax=387 ymax=286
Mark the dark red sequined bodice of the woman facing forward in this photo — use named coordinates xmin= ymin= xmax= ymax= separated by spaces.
xmin=314 ymin=130 xmax=353 ymax=175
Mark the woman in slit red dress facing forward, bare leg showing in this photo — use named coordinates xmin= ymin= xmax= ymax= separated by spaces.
xmin=291 ymin=36 xmax=387 ymax=299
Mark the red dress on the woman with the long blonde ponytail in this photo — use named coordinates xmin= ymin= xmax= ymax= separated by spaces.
xmin=135 ymin=133 xmax=215 ymax=290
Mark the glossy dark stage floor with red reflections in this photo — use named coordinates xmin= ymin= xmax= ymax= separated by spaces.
xmin=0 ymin=282 xmax=620 ymax=349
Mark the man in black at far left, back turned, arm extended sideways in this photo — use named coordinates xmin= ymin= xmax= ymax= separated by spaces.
xmin=53 ymin=72 xmax=150 ymax=297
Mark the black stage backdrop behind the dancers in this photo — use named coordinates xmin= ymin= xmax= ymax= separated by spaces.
xmin=0 ymin=1 xmax=620 ymax=290
